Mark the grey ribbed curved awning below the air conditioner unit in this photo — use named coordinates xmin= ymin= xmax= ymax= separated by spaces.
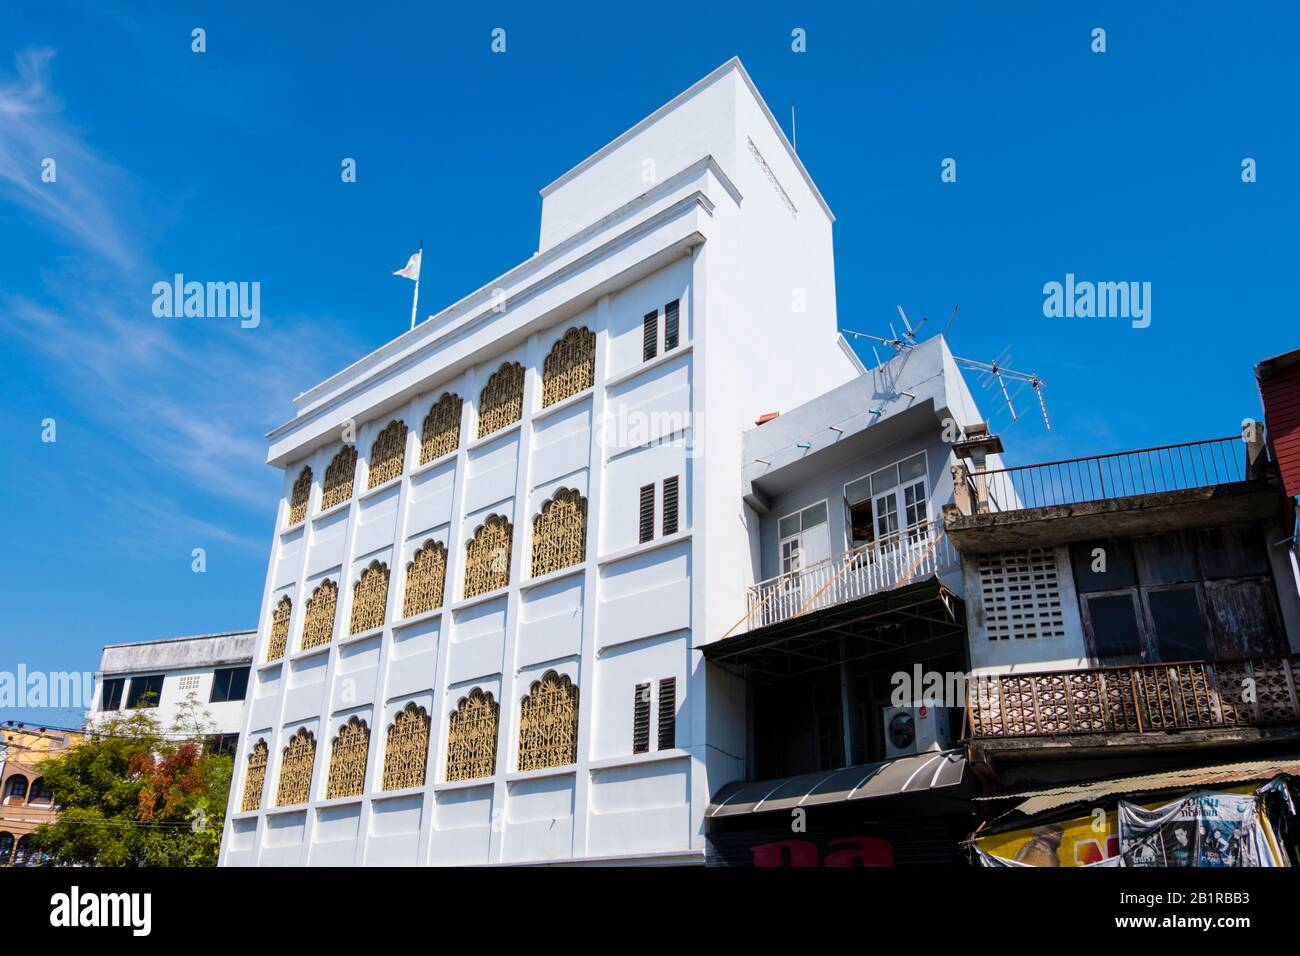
xmin=705 ymin=749 xmax=971 ymax=819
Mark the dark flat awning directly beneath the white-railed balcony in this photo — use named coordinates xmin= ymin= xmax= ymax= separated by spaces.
xmin=697 ymin=578 xmax=966 ymax=683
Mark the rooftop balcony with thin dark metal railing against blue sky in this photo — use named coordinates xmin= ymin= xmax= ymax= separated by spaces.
xmin=944 ymin=437 xmax=1279 ymax=551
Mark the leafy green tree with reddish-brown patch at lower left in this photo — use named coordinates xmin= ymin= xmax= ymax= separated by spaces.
xmin=31 ymin=693 xmax=234 ymax=866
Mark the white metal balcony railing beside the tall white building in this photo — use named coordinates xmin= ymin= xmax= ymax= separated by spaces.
xmin=733 ymin=524 xmax=959 ymax=630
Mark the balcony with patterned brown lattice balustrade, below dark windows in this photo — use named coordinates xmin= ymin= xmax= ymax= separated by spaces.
xmin=966 ymin=656 xmax=1300 ymax=749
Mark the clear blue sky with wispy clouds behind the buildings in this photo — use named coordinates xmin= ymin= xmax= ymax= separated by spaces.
xmin=0 ymin=0 xmax=1300 ymax=722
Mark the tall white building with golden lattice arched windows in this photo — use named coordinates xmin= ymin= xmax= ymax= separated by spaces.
xmin=221 ymin=60 xmax=862 ymax=865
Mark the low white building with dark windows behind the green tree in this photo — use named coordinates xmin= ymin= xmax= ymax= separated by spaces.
xmin=86 ymin=631 xmax=257 ymax=753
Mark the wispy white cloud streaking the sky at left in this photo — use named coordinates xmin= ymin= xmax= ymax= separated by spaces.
xmin=0 ymin=49 xmax=356 ymax=530
